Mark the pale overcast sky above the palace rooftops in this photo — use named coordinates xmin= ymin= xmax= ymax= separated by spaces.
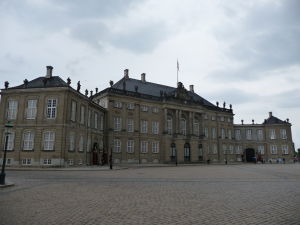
xmin=0 ymin=0 xmax=300 ymax=149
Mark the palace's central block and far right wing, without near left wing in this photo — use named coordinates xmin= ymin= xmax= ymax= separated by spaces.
xmin=93 ymin=70 xmax=294 ymax=163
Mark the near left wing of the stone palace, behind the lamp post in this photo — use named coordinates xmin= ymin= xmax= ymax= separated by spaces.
xmin=0 ymin=66 xmax=107 ymax=166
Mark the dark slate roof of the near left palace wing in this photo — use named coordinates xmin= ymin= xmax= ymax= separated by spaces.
xmin=8 ymin=76 xmax=68 ymax=89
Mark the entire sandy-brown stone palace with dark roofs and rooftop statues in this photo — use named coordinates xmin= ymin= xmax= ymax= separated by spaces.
xmin=0 ymin=66 xmax=294 ymax=166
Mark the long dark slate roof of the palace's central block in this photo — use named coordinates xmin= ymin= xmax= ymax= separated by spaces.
xmin=98 ymin=77 xmax=232 ymax=112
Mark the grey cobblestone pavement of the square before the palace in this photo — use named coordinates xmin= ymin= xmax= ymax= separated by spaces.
xmin=0 ymin=164 xmax=300 ymax=225
